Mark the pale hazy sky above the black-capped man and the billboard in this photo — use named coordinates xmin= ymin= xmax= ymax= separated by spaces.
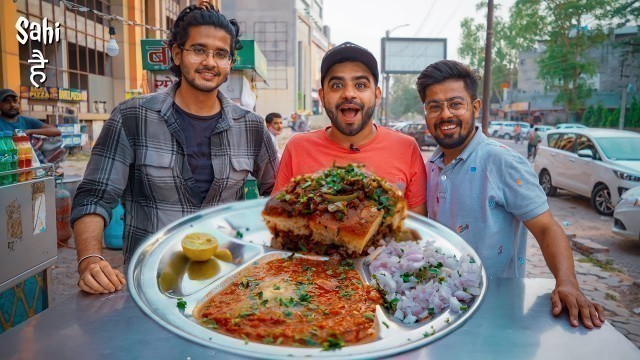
xmin=323 ymin=0 xmax=515 ymax=63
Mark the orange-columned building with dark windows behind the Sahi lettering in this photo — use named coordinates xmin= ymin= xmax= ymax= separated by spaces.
xmin=0 ymin=0 xmax=202 ymax=143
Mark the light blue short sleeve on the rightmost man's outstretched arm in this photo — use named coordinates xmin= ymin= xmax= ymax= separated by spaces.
xmin=491 ymin=149 xmax=549 ymax=221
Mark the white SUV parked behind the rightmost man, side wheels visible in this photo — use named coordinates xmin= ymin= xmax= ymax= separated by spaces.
xmin=533 ymin=128 xmax=640 ymax=216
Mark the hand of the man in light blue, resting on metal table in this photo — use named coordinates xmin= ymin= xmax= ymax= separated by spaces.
xmin=551 ymin=280 xmax=604 ymax=329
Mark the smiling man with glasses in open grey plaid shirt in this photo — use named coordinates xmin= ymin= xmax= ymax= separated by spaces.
xmin=71 ymin=2 xmax=278 ymax=293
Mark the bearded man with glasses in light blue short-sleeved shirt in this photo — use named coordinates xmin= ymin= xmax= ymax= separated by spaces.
xmin=416 ymin=60 xmax=604 ymax=328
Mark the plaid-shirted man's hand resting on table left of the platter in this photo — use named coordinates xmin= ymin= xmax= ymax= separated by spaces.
xmin=78 ymin=257 xmax=126 ymax=294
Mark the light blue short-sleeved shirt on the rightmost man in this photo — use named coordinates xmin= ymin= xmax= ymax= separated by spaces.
xmin=427 ymin=129 xmax=549 ymax=278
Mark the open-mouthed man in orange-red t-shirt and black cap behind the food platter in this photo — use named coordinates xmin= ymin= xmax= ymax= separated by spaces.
xmin=273 ymin=42 xmax=427 ymax=215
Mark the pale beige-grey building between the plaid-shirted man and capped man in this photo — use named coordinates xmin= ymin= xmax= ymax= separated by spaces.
xmin=221 ymin=0 xmax=330 ymax=121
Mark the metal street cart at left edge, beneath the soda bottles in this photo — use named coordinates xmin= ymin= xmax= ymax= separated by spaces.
xmin=0 ymin=165 xmax=57 ymax=334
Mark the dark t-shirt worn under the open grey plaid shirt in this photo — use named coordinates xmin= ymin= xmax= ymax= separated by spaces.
xmin=174 ymin=103 xmax=222 ymax=204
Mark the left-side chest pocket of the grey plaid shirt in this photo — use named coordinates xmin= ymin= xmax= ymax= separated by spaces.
xmin=134 ymin=152 xmax=181 ymax=205
